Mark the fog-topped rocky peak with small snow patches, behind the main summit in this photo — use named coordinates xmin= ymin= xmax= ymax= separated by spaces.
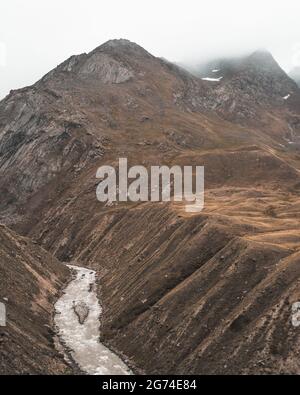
xmin=185 ymin=51 xmax=300 ymax=124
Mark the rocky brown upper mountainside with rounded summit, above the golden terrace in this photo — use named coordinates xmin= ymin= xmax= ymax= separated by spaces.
xmin=0 ymin=41 xmax=300 ymax=233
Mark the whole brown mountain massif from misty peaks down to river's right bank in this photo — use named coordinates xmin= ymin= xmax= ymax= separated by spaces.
xmin=0 ymin=40 xmax=300 ymax=374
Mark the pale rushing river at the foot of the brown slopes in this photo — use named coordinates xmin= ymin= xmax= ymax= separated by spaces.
xmin=55 ymin=266 xmax=131 ymax=375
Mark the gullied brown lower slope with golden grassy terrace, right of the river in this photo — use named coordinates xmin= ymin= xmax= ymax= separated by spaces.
xmin=8 ymin=130 xmax=300 ymax=374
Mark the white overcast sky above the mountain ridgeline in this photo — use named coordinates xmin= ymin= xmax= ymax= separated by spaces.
xmin=0 ymin=0 xmax=300 ymax=98
